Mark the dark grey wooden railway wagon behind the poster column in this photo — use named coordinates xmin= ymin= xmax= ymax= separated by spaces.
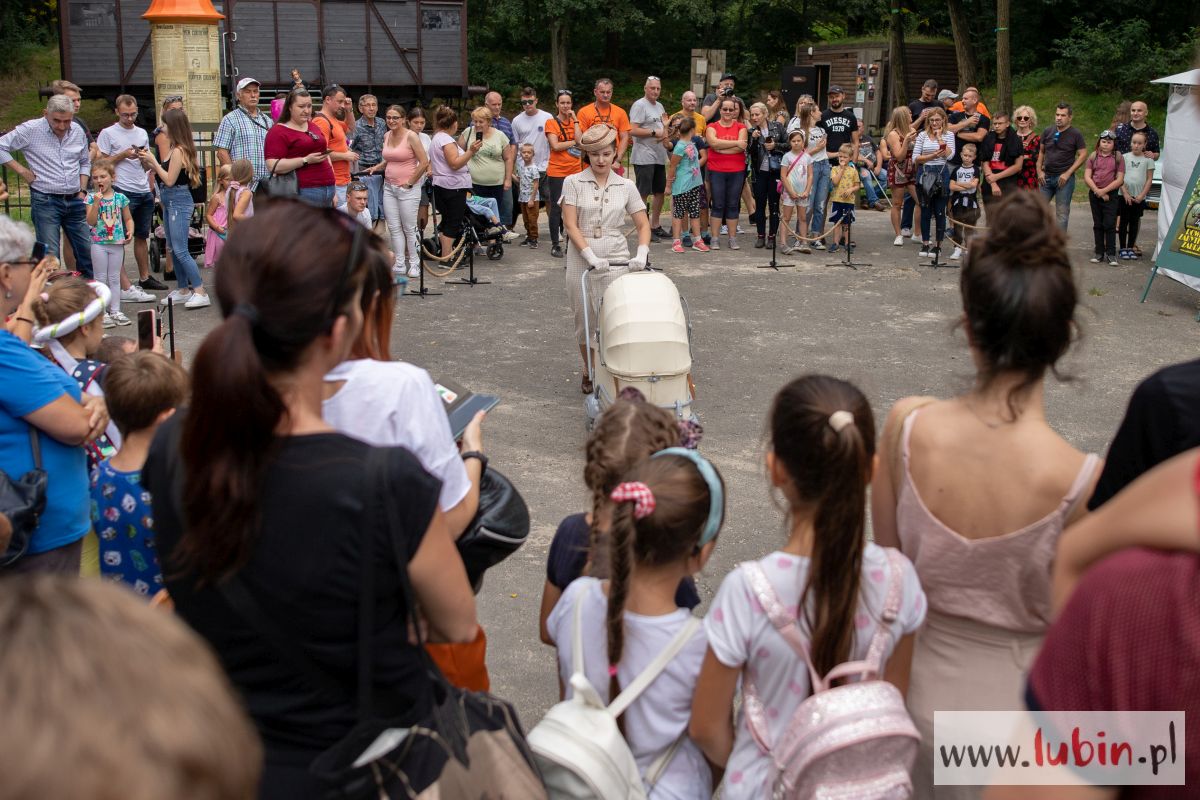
xmin=59 ymin=0 xmax=468 ymax=102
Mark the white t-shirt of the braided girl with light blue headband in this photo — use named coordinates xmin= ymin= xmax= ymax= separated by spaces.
xmin=546 ymin=578 xmax=713 ymax=800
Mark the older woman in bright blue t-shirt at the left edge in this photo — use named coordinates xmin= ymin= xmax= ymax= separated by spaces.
xmin=0 ymin=216 xmax=108 ymax=577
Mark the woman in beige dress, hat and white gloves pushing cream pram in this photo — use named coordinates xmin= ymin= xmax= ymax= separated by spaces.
xmin=562 ymin=124 xmax=650 ymax=395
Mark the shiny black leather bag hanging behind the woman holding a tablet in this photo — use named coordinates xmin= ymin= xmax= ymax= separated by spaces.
xmin=457 ymin=467 xmax=529 ymax=594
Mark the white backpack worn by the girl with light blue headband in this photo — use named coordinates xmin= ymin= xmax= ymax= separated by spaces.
xmin=528 ymin=593 xmax=700 ymax=800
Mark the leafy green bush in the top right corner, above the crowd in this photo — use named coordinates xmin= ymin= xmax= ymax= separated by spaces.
xmin=1055 ymin=17 xmax=1200 ymax=92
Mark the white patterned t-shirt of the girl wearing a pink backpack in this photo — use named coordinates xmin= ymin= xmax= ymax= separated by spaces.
xmin=704 ymin=543 xmax=925 ymax=800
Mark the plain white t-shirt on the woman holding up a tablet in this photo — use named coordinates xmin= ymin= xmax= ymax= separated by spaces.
xmin=322 ymin=359 xmax=470 ymax=511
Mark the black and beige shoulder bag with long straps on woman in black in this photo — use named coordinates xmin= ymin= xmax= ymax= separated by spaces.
xmin=221 ymin=447 xmax=546 ymax=800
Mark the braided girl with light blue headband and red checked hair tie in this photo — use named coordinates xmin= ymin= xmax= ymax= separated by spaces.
xmin=546 ymin=447 xmax=725 ymax=800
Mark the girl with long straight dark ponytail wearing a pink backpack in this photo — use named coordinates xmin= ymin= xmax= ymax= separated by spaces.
xmin=691 ymin=375 xmax=925 ymax=800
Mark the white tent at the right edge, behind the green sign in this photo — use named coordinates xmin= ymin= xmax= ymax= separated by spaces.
xmin=1151 ymin=68 xmax=1200 ymax=290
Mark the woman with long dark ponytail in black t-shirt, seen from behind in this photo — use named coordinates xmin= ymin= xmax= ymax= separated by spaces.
xmin=144 ymin=200 xmax=478 ymax=800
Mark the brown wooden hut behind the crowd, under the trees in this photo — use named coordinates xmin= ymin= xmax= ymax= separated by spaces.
xmin=796 ymin=40 xmax=964 ymax=130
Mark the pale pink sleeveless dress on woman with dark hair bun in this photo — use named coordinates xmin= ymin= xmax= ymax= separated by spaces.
xmin=896 ymin=410 xmax=1100 ymax=800
